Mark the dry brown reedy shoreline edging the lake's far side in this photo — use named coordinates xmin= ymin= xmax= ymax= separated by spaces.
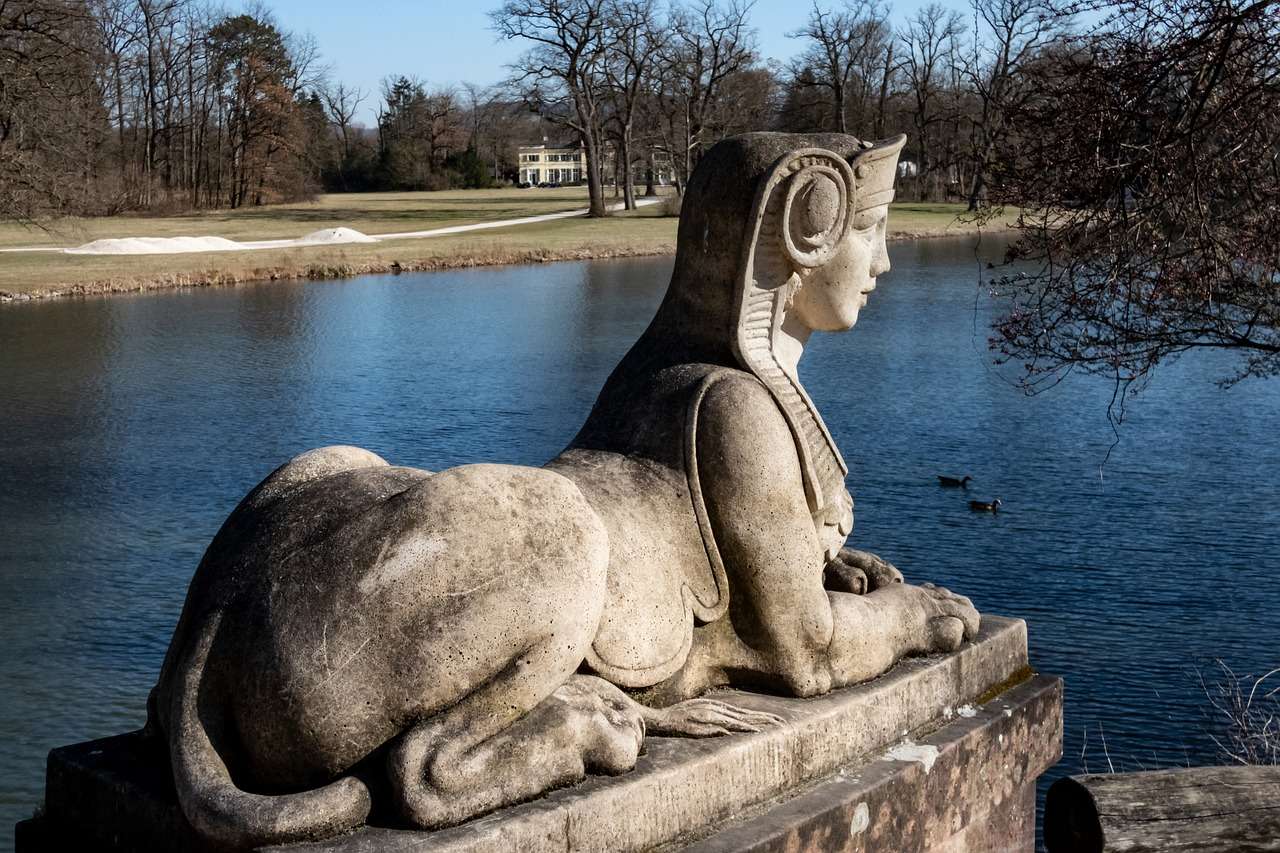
xmin=0 ymin=225 xmax=1016 ymax=305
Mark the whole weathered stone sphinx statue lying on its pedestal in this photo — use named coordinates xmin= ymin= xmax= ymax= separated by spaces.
xmin=147 ymin=133 xmax=979 ymax=847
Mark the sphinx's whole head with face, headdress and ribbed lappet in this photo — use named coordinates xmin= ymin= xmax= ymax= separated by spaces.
xmin=646 ymin=133 xmax=906 ymax=514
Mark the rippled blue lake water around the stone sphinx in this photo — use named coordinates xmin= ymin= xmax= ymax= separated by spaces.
xmin=0 ymin=241 xmax=1280 ymax=848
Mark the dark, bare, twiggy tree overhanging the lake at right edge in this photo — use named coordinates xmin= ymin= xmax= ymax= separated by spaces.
xmin=992 ymin=0 xmax=1280 ymax=399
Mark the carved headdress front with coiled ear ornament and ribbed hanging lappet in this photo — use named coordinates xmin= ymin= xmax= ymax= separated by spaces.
xmin=733 ymin=134 xmax=906 ymax=515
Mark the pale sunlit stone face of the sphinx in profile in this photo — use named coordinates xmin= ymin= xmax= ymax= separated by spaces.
xmin=788 ymin=205 xmax=890 ymax=332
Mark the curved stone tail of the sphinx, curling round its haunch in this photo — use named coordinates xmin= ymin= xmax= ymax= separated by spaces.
xmin=168 ymin=615 xmax=371 ymax=848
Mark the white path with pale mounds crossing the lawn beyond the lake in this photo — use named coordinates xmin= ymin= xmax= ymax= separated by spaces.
xmin=0 ymin=199 xmax=662 ymax=255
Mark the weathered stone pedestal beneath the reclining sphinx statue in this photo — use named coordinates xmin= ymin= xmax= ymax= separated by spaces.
xmin=18 ymin=616 xmax=1062 ymax=853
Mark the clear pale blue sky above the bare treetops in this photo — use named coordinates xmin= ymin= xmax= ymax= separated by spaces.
xmin=266 ymin=0 xmax=969 ymax=126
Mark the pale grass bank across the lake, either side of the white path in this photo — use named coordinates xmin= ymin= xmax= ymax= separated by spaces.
xmin=0 ymin=188 xmax=1018 ymax=301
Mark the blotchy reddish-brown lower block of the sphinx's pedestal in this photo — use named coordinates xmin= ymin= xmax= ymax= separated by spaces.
xmin=685 ymin=676 xmax=1062 ymax=853
